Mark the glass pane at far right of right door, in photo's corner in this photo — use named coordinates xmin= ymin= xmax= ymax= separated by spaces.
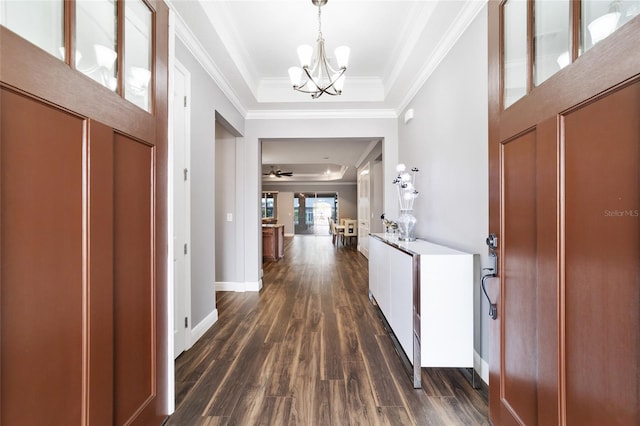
xmin=580 ymin=0 xmax=640 ymax=53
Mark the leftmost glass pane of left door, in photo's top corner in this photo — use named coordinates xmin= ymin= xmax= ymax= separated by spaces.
xmin=0 ymin=0 xmax=65 ymax=61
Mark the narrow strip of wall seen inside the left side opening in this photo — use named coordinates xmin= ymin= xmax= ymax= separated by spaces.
xmin=215 ymin=122 xmax=236 ymax=283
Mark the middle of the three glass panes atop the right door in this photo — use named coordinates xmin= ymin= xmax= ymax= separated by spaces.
xmin=533 ymin=0 xmax=571 ymax=86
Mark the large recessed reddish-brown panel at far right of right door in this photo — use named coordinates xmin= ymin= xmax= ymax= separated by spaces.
xmin=560 ymin=83 xmax=640 ymax=425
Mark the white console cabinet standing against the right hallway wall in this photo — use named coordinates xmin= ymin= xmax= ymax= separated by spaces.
xmin=369 ymin=234 xmax=474 ymax=387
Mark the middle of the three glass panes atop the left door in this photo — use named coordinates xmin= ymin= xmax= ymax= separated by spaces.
xmin=75 ymin=0 xmax=118 ymax=90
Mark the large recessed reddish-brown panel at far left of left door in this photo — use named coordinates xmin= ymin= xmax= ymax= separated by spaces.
xmin=0 ymin=88 xmax=87 ymax=425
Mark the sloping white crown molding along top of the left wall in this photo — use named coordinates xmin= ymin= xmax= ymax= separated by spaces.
xmin=166 ymin=0 xmax=247 ymax=117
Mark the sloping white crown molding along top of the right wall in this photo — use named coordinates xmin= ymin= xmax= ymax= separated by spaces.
xmin=396 ymin=0 xmax=487 ymax=116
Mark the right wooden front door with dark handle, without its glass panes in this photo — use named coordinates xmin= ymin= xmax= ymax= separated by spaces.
xmin=489 ymin=2 xmax=640 ymax=426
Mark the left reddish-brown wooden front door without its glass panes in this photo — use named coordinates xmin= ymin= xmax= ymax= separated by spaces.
xmin=0 ymin=2 xmax=168 ymax=426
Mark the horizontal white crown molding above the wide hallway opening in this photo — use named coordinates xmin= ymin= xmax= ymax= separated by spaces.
xmin=245 ymin=109 xmax=398 ymax=120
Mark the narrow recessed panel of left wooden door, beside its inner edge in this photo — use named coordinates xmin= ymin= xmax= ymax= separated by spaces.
xmin=113 ymin=133 xmax=157 ymax=424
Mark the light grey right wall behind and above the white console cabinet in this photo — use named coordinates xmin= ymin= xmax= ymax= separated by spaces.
xmin=398 ymin=5 xmax=490 ymax=376
